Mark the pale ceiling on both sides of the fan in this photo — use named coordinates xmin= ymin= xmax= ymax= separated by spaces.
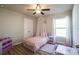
xmin=2 ymin=4 xmax=73 ymax=16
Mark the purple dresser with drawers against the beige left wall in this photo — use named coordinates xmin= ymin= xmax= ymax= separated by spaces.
xmin=0 ymin=37 xmax=12 ymax=54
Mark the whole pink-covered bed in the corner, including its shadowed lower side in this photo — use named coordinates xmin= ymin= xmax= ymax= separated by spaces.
xmin=23 ymin=36 xmax=49 ymax=52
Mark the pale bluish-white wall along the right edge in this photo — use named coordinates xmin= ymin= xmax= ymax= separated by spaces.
xmin=72 ymin=4 xmax=79 ymax=45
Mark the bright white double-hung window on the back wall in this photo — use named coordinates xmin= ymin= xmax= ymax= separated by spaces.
xmin=55 ymin=16 xmax=69 ymax=38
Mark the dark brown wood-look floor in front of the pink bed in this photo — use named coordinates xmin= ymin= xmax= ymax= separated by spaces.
xmin=4 ymin=44 xmax=34 ymax=55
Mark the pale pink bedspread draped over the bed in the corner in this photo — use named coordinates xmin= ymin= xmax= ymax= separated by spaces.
xmin=24 ymin=36 xmax=48 ymax=51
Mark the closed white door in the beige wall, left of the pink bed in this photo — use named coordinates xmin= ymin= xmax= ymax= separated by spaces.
xmin=24 ymin=18 xmax=33 ymax=38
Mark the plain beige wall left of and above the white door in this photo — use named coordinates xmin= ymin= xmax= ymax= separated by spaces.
xmin=0 ymin=8 xmax=36 ymax=45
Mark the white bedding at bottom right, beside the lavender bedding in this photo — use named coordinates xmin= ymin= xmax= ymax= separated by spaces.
xmin=56 ymin=45 xmax=78 ymax=55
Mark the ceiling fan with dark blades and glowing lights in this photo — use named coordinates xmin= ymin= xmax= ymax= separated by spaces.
xmin=27 ymin=4 xmax=50 ymax=15
